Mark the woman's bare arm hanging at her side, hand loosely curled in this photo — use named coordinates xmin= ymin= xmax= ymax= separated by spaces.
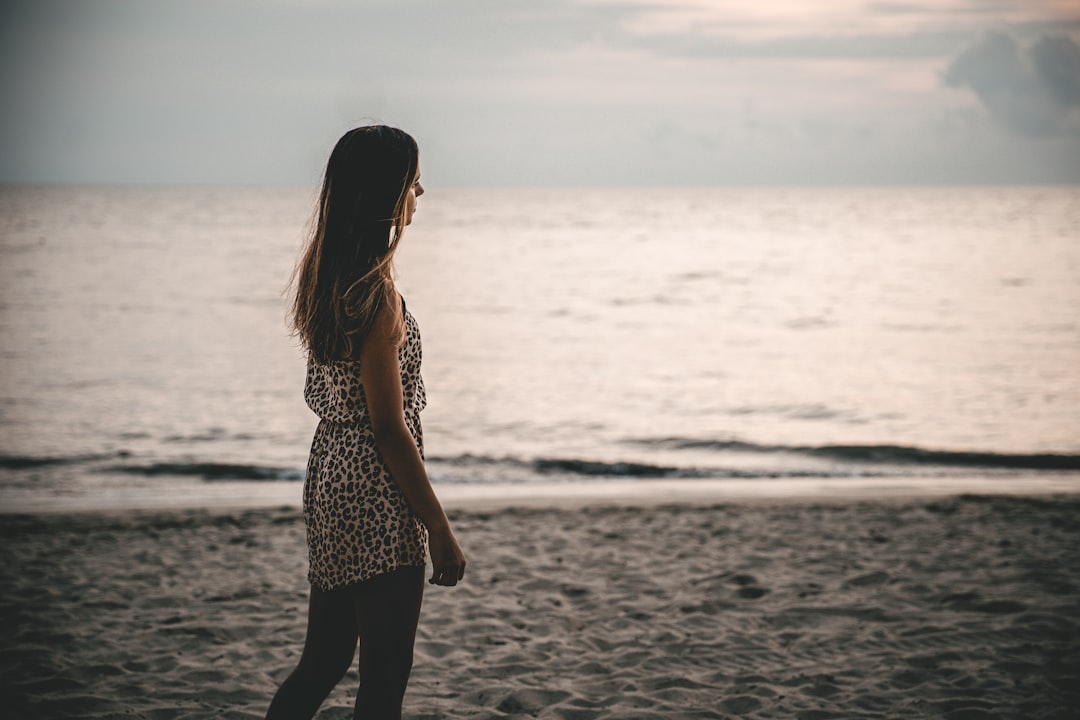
xmin=360 ymin=294 xmax=465 ymax=585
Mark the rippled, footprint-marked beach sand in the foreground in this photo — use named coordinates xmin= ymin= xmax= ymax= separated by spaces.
xmin=0 ymin=495 xmax=1080 ymax=720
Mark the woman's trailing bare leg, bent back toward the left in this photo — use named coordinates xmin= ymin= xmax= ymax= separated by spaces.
xmin=267 ymin=586 xmax=356 ymax=720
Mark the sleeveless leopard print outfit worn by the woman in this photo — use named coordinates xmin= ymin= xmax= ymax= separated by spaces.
xmin=303 ymin=302 xmax=428 ymax=590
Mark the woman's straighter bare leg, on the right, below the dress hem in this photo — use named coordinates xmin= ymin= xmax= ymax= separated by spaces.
xmin=352 ymin=567 xmax=424 ymax=720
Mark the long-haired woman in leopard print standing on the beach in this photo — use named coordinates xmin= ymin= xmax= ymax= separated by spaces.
xmin=267 ymin=125 xmax=465 ymax=720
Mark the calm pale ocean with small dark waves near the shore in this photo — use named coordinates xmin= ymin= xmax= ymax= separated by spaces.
xmin=0 ymin=187 xmax=1080 ymax=510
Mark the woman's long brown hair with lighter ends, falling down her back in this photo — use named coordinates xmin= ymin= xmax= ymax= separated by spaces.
xmin=289 ymin=125 xmax=419 ymax=363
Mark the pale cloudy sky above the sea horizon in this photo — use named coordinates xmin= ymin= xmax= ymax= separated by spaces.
xmin=0 ymin=0 xmax=1080 ymax=187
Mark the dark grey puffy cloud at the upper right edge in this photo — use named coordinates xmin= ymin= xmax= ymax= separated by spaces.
xmin=942 ymin=32 xmax=1080 ymax=137
